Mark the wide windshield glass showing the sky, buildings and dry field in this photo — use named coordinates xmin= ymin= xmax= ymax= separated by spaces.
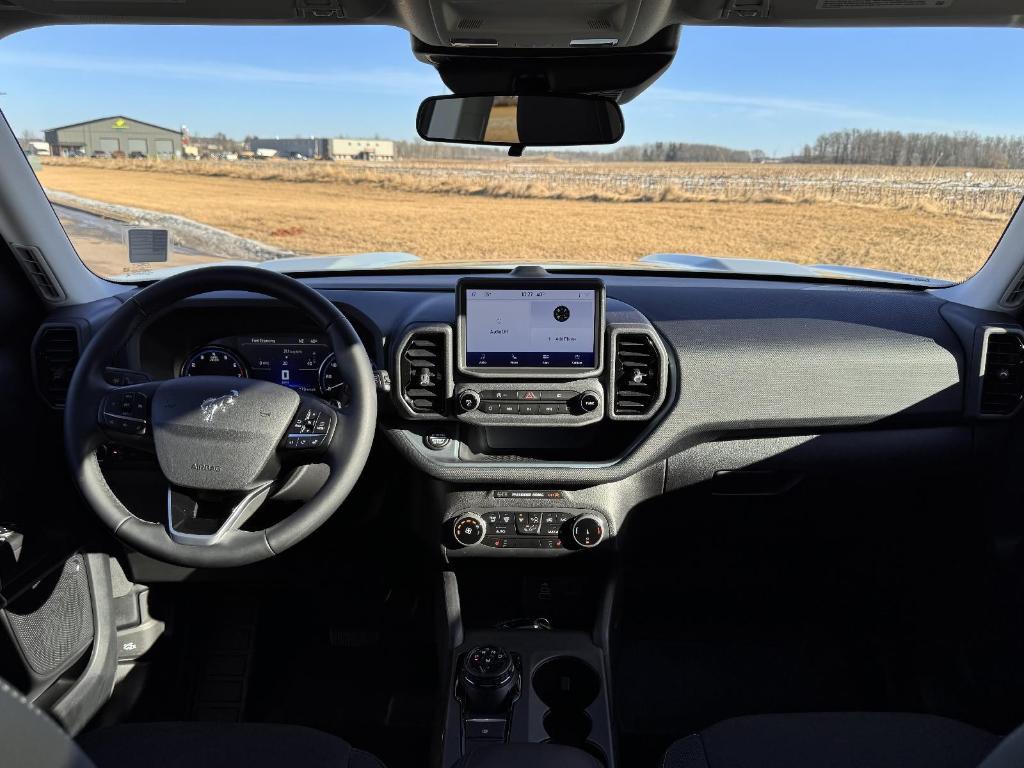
xmin=0 ymin=27 xmax=1024 ymax=281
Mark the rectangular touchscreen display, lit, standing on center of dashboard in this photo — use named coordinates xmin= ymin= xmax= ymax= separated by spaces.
xmin=464 ymin=286 xmax=599 ymax=369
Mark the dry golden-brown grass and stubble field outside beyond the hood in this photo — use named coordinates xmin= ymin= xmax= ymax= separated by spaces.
xmin=39 ymin=158 xmax=1024 ymax=280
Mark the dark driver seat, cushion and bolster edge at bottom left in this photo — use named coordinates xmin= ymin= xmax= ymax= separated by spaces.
xmin=0 ymin=680 xmax=384 ymax=768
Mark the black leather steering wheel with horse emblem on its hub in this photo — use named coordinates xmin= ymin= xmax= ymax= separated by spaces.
xmin=63 ymin=266 xmax=377 ymax=567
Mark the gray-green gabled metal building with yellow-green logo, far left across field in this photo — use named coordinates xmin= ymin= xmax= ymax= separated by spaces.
xmin=45 ymin=115 xmax=181 ymax=160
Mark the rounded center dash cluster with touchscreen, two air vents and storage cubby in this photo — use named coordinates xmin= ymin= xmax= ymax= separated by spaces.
xmin=391 ymin=267 xmax=672 ymax=477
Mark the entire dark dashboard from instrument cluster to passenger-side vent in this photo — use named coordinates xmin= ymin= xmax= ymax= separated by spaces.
xmin=44 ymin=269 xmax=1024 ymax=556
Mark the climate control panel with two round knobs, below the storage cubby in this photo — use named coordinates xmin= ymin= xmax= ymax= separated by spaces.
xmin=446 ymin=507 xmax=607 ymax=551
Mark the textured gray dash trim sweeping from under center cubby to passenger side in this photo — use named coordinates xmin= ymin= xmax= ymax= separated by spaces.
xmin=386 ymin=286 xmax=963 ymax=487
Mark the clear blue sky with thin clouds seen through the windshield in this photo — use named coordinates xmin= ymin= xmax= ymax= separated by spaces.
xmin=0 ymin=27 xmax=1024 ymax=155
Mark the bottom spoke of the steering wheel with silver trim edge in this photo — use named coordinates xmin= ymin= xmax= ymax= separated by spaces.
xmin=167 ymin=481 xmax=273 ymax=547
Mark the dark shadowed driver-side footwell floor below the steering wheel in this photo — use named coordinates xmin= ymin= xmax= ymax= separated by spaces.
xmin=117 ymin=568 xmax=437 ymax=768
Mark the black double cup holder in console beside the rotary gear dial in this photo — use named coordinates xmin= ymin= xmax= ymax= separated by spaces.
xmin=532 ymin=656 xmax=605 ymax=763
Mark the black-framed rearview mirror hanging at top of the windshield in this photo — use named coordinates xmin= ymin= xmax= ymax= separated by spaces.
xmin=416 ymin=95 xmax=625 ymax=147
